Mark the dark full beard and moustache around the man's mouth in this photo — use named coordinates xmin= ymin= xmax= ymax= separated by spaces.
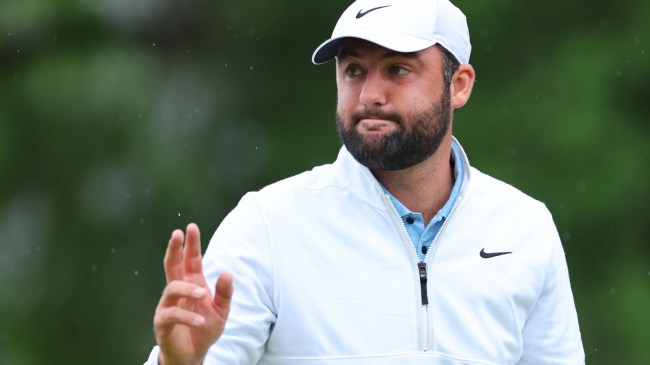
xmin=336 ymin=88 xmax=451 ymax=171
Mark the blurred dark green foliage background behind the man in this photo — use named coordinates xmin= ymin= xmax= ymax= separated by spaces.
xmin=0 ymin=0 xmax=650 ymax=365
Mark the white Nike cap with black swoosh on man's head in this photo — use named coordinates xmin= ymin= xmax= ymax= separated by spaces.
xmin=312 ymin=0 xmax=472 ymax=65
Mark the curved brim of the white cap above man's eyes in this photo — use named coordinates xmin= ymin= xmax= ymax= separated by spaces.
xmin=311 ymin=29 xmax=437 ymax=65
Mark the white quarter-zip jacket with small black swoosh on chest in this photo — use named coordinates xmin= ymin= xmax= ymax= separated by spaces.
xmin=148 ymin=139 xmax=584 ymax=365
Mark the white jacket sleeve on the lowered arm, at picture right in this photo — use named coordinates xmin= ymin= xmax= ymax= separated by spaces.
xmin=518 ymin=213 xmax=585 ymax=365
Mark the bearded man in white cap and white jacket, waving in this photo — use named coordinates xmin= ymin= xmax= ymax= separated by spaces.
xmin=148 ymin=0 xmax=584 ymax=365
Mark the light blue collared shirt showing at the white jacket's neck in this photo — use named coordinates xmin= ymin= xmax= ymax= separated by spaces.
xmin=382 ymin=143 xmax=465 ymax=261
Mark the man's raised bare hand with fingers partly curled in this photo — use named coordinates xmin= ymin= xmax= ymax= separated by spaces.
xmin=154 ymin=223 xmax=233 ymax=365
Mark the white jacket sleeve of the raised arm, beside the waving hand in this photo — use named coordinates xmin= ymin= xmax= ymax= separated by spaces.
xmin=203 ymin=193 xmax=276 ymax=365
